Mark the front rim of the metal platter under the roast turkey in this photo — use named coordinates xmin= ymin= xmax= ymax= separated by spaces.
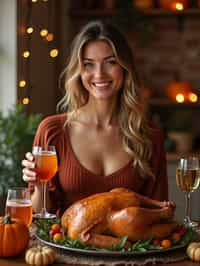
xmin=35 ymin=233 xmax=187 ymax=258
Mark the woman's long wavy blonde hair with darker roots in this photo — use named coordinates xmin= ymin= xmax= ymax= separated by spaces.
xmin=59 ymin=21 xmax=153 ymax=176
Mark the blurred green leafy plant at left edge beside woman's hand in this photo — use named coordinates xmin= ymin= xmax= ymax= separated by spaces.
xmin=0 ymin=105 xmax=41 ymax=195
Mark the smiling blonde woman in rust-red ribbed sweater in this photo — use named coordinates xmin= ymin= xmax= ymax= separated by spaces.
xmin=22 ymin=21 xmax=168 ymax=216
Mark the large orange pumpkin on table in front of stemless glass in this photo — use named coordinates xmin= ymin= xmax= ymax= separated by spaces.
xmin=0 ymin=215 xmax=29 ymax=257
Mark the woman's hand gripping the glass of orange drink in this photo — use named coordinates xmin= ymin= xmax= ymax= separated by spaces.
xmin=22 ymin=152 xmax=39 ymax=185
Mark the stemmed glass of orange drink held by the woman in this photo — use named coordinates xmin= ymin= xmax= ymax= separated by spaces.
xmin=32 ymin=146 xmax=58 ymax=219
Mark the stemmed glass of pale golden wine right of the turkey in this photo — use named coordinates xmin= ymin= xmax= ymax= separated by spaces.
xmin=176 ymin=157 xmax=200 ymax=227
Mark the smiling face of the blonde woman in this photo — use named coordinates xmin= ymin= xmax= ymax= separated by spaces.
xmin=80 ymin=40 xmax=124 ymax=100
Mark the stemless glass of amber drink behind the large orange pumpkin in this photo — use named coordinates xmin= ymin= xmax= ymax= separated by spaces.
xmin=6 ymin=187 xmax=32 ymax=226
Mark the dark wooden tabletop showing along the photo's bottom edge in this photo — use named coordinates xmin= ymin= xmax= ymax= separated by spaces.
xmin=0 ymin=257 xmax=199 ymax=266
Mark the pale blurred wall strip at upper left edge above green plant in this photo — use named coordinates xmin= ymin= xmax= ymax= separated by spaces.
xmin=0 ymin=0 xmax=17 ymax=112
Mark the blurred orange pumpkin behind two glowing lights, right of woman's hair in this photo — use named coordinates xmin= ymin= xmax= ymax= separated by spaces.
xmin=165 ymin=81 xmax=192 ymax=101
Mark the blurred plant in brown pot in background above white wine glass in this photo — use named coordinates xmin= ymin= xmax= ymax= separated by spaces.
xmin=167 ymin=109 xmax=193 ymax=153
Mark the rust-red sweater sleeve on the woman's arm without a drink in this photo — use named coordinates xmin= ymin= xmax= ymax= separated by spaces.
xmin=142 ymin=129 xmax=168 ymax=201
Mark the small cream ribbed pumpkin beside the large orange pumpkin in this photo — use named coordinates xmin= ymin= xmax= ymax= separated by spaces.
xmin=25 ymin=245 xmax=55 ymax=266
